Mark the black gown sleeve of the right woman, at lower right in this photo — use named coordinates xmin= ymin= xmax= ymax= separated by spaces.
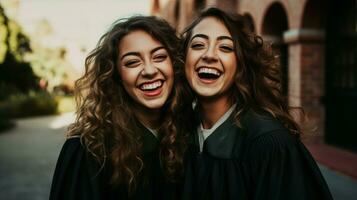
xmin=244 ymin=130 xmax=332 ymax=200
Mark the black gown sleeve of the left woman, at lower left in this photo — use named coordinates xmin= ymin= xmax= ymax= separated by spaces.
xmin=49 ymin=138 xmax=101 ymax=200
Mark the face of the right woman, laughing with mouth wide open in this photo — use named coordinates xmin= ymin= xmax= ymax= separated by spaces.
xmin=185 ymin=17 xmax=237 ymax=99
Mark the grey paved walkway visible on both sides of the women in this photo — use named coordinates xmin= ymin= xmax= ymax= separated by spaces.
xmin=0 ymin=113 xmax=357 ymax=200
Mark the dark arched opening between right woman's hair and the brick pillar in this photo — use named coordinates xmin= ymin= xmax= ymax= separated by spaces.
xmin=262 ymin=3 xmax=288 ymax=96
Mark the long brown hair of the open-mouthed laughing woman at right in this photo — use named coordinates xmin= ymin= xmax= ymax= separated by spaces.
xmin=182 ymin=7 xmax=302 ymax=135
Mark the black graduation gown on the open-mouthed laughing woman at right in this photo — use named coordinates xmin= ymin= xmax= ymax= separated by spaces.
xmin=183 ymin=112 xmax=332 ymax=200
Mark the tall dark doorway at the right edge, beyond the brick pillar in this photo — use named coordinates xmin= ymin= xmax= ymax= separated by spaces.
xmin=325 ymin=0 xmax=357 ymax=151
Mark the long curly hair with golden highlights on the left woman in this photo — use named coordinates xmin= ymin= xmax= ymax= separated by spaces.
xmin=68 ymin=16 xmax=186 ymax=192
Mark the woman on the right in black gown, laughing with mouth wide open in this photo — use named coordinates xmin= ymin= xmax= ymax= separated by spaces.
xmin=179 ymin=8 xmax=332 ymax=200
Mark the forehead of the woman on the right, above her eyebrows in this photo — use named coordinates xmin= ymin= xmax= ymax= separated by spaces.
xmin=192 ymin=16 xmax=232 ymax=37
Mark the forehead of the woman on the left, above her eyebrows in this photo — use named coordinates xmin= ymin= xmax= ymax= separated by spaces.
xmin=119 ymin=30 xmax=162 ymax=54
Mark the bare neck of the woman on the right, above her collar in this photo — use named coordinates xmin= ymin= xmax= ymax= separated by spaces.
xmin=199 ymin=97 xmax=232 ymax=129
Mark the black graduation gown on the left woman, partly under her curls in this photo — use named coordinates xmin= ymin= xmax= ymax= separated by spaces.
xmin=50 ymin=127 xmax=177 ymax=200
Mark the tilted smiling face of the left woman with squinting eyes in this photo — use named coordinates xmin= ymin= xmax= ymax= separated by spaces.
xmin=118 ymin=30 xmax=174 ymax=110
